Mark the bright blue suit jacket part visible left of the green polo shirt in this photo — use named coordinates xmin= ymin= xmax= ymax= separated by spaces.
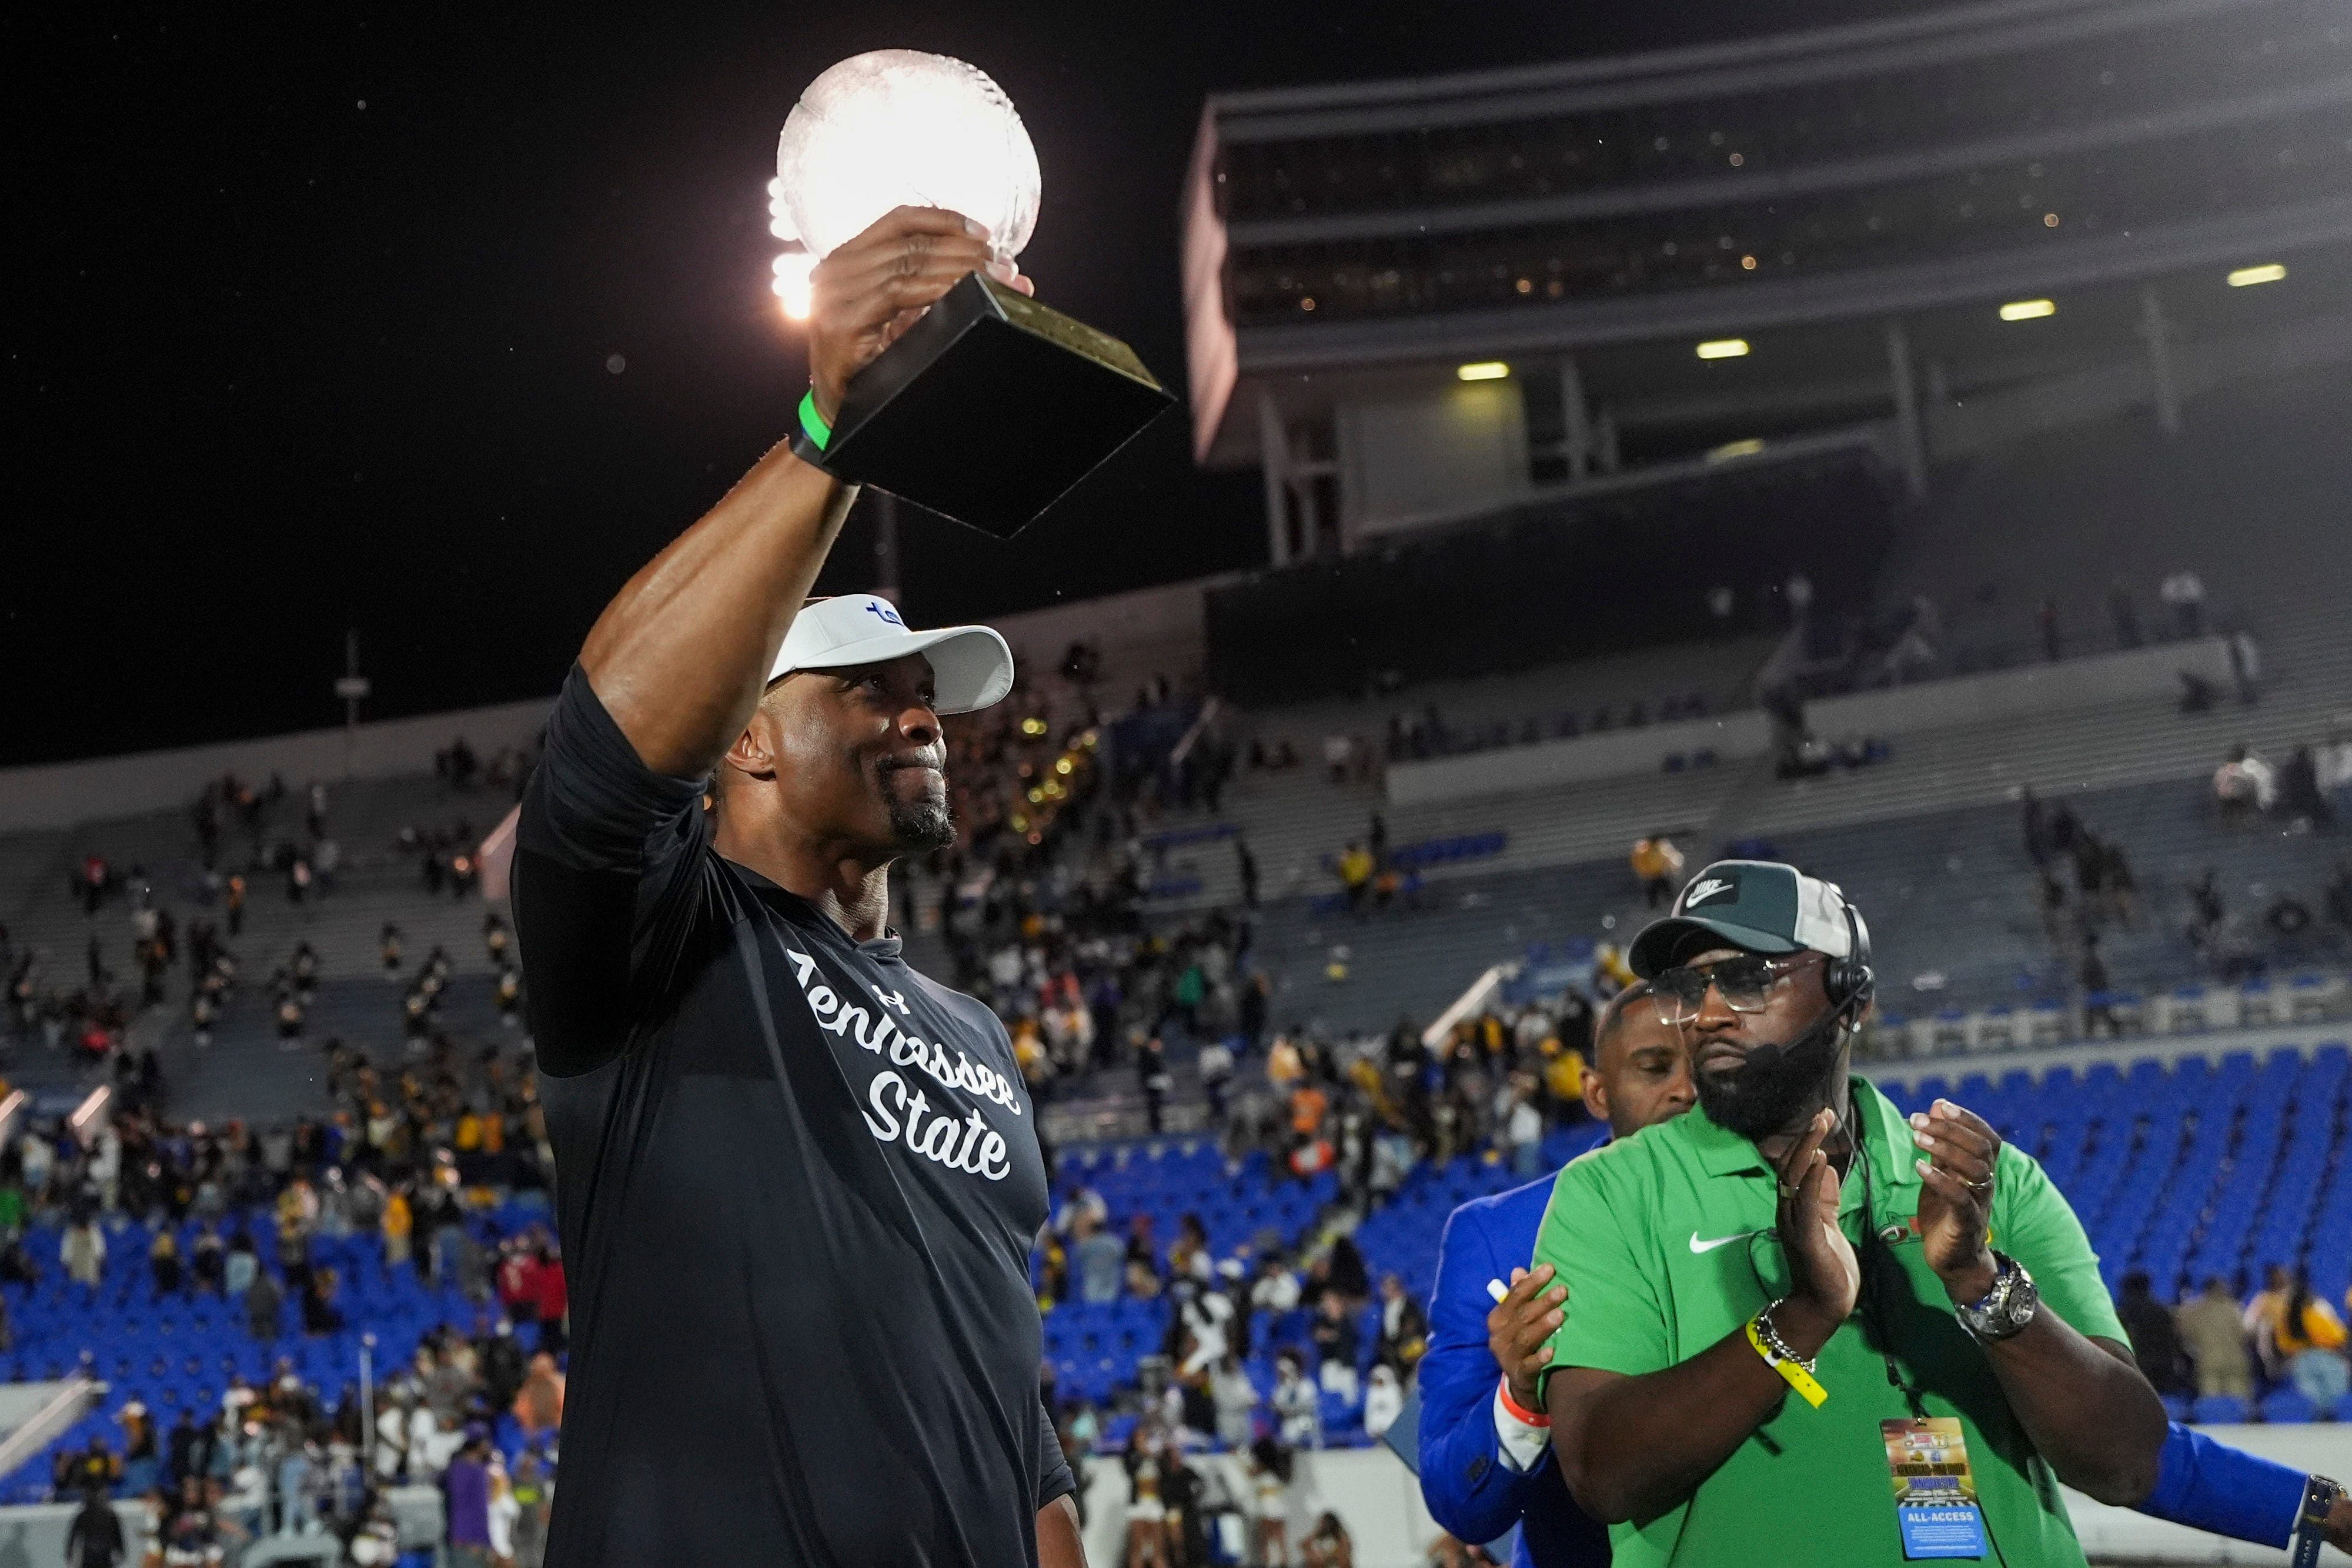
xmin=1418 ymin=1142 xmax=1609 ymax=1568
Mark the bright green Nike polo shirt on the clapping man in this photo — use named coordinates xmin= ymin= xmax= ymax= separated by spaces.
xmin=1536 ymin=1079 xmax=2129 ymax=1568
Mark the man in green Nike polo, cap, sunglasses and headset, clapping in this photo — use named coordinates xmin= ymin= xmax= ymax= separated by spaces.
xmin=1536 ymin=860 xmax=2166 ymax=1568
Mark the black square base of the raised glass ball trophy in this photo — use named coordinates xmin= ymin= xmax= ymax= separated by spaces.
xmin=826 ymin=273 xmax=1176 ymax=539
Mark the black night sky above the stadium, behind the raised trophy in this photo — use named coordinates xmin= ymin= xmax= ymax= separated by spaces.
xmin=0 ymin=0 xmax=1884 ymax=762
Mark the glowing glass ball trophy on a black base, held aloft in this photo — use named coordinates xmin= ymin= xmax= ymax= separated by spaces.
xmin=769 ymin=49 xmax=1174 ymax=539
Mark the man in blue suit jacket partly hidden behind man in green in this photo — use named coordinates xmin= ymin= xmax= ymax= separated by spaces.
xmin=1418 ymin=982 xmax=2352 ymax=1568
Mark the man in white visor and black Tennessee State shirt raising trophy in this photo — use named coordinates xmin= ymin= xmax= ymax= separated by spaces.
xmin=513 ymin=56 xmax=1157 ymax=1568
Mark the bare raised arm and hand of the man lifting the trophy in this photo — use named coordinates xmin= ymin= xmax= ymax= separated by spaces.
xmin=581 ymin=207 xmax=1011 ymax=778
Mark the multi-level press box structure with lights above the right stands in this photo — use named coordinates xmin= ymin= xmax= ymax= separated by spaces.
xmin=1183 ymin=0 xmax=2352 ymax=562
